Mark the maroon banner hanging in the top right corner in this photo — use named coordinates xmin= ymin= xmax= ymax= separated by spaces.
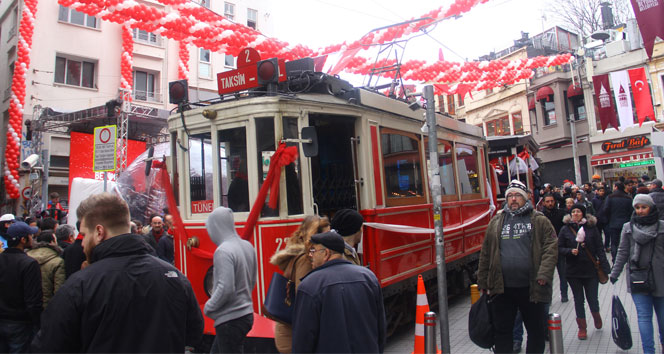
xmin=631 ymin=0 xmax=664 ymax=58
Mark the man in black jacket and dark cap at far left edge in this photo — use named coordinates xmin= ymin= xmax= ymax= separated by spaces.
xmin=0 ymin=222 xmax=42 ymax=353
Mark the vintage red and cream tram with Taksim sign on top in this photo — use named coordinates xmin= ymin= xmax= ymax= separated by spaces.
xmin=168 ymin=56 xmax=493 ymax=337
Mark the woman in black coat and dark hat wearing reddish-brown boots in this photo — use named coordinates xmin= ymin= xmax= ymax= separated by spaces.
xmin=558 ymin=204 xmax=610 ymax=339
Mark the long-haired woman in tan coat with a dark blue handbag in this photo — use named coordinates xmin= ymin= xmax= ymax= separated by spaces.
xmin=270 ymin=215 xmax=330 ymax=353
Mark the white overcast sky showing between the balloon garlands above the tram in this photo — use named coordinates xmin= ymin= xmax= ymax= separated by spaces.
xmin=273 ymin=0 xmax=556 ymax=61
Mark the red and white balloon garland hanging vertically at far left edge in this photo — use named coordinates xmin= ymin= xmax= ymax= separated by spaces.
xmin=4 ymin=0 xmax=37 ymax=199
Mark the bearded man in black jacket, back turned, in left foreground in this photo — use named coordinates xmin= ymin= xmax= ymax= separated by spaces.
xmin=32 ymin=193 xmax=203 ymax=353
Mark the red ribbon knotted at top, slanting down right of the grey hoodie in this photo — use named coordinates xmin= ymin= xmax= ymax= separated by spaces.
xmin=242 ymin=143 xmax=297 ymax=241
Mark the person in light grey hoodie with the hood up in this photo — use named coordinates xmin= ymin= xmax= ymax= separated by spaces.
xmin=203 ymin=207 xmax=257 ymax=353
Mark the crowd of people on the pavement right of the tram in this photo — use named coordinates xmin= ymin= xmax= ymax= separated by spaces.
xmin=478 ymin=176 xmax=664 ymax=353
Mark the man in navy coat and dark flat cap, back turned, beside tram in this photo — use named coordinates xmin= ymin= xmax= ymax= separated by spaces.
xmin=293 ymin=231 xmax=386 ymax=353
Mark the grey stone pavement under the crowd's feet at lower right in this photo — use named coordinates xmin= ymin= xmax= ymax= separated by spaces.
xmin=385 ymin=266 xmax=662 ymax=353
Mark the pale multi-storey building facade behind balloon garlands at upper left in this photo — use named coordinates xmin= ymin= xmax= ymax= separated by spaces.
xmin=0 ymin=0 xmax=273 ymax=210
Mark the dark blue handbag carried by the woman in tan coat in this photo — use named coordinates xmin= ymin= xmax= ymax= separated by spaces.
xmin=261 ymin=255 xmax=302 ymax=324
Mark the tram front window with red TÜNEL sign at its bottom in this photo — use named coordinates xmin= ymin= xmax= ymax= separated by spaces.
xmin=189 ymin=133 xmax=213 ymax=214
